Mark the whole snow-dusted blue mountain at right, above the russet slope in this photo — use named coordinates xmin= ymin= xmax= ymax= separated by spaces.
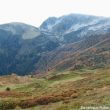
xmin=40 ymin=14 xmax=110 ymax=43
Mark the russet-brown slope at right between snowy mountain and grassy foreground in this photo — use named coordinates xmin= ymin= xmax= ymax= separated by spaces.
xmin=37 ymin=34 xmax=110 ymax=72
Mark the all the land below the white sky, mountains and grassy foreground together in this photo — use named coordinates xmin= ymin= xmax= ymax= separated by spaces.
xmin=0 ymin=14 xmax=110 ymax=110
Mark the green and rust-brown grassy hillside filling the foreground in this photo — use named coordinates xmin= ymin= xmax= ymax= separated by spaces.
xmin=0 ymin=66 xmax=110 ymax=110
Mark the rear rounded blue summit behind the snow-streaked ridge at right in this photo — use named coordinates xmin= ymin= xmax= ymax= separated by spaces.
xmin=40 ymin=14 xmax=100 ymax=33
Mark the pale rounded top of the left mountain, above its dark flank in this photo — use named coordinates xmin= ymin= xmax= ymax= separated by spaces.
xmin=0 ymin=22 xmax=40 ymax=39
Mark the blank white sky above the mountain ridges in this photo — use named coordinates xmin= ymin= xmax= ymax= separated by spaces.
xmin=0 ymin=0 xmax=110 ymax=27
